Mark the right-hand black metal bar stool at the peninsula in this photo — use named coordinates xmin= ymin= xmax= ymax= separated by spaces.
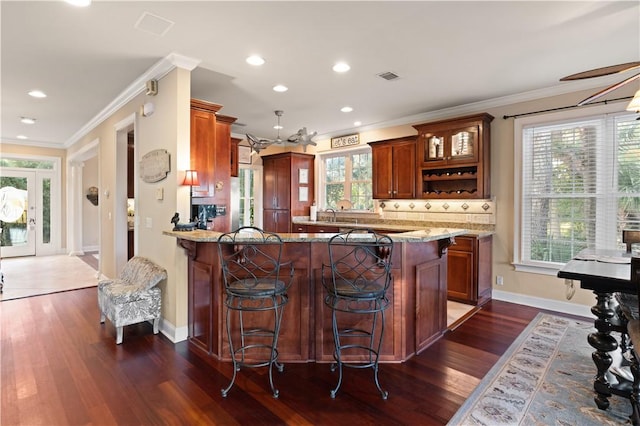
xmin=322 ymin=230 xmax=393 ymax=399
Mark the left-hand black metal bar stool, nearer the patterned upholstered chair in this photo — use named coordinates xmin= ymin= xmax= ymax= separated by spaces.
xmin=218 ymin=227 xmax=294 ymax=398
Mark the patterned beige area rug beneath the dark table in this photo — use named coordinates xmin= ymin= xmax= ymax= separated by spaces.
xmin=448 ymin=313 xmax=631 ymax=426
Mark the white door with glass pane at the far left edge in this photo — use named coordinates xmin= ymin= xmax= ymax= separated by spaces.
xmin=0 ymin=169 xmax=37 ymax=257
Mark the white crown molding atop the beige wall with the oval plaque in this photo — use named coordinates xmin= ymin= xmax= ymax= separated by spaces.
xmin=64 ymin=53 xmax=201 ymax=148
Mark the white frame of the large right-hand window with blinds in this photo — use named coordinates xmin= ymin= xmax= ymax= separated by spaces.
xmin=512 ymin=102 xmax=630 ymax=276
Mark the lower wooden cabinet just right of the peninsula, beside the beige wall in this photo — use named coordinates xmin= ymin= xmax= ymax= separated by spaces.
xmin=447 ymin=235 xmax=493 ymax=305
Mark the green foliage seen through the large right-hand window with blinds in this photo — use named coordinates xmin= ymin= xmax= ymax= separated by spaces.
xmin=524 ymin=115 xmax=640 ymax=263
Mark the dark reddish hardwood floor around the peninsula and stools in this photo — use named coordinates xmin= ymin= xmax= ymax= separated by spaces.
xmin=0 ymin=288 xmax=560 ymax=426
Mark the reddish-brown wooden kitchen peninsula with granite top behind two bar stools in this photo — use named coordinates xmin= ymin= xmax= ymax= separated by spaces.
xmin=164 ymin=228 xmax=467 ymax=362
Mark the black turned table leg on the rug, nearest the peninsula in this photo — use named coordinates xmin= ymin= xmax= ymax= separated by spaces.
xmin=588 ymin=291 xmax=618 ymax=410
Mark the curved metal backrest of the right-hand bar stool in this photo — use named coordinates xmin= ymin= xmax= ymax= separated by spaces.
xmin=323 ymin=230 xmax=393 ymax=294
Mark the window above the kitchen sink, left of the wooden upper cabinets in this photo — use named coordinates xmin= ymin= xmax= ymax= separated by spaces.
xmin=320 ymin=148 xmax=373 ymax=210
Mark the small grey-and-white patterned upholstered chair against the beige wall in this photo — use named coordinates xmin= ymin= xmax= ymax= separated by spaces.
xmin=98 ymin=256 xmax=167 ymax=345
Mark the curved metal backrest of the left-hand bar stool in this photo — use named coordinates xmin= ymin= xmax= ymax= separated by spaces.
xmin=218 ymin=226 xmax=288 ymax=291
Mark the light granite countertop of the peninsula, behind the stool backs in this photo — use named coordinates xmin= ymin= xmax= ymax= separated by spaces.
xmin=162 ymin=226 xmax=469 ymax=243
